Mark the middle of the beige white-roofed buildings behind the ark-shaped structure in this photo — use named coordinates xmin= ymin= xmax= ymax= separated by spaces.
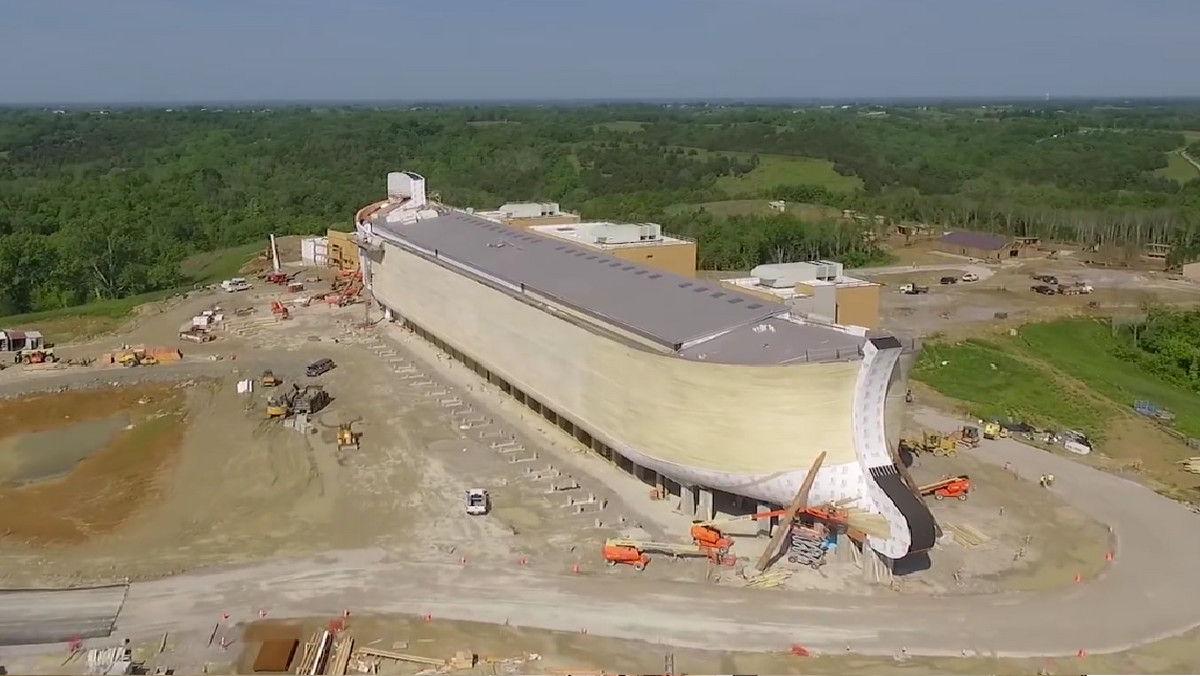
xmin=528 ymin=222 xmax=696 ymax=277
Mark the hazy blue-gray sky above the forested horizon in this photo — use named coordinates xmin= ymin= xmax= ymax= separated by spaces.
xmin=0 ymin=0 xmax=1200 ymax=103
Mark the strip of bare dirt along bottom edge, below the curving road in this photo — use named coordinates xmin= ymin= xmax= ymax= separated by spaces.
xmin=9 ymin=616 xmax=1200 ymax=676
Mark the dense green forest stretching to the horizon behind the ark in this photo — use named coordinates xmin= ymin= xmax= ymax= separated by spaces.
xmin=0 ymin=104 xmax=1200 ymax=315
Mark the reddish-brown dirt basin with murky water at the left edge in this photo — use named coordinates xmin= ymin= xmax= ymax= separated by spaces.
xmin=0 ymin=384 xmax=186 ymax=544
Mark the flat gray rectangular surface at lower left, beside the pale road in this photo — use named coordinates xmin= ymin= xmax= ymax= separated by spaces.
xmin=0 ymin=585 xmax=126 ymax=646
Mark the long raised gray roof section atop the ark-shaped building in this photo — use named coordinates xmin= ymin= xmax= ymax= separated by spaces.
xmin=374 ymin=211 xmax=796 ymax=349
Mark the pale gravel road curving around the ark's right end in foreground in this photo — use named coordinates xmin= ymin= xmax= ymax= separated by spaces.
xmin=9 ymin=413 xmax=1200 ymax=657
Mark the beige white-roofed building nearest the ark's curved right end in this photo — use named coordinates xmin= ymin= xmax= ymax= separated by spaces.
xmin=721 ymin=261 xmax=881 ymax=329
